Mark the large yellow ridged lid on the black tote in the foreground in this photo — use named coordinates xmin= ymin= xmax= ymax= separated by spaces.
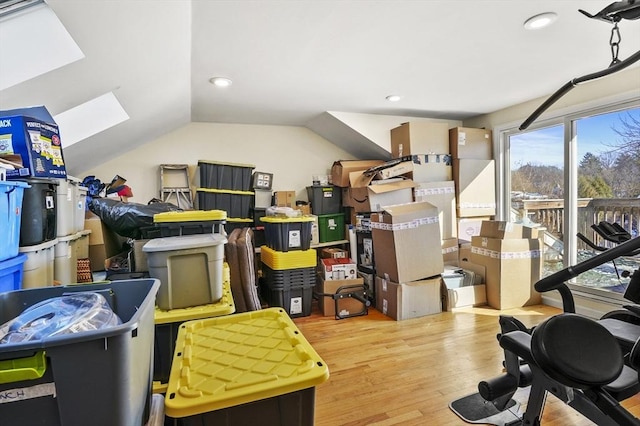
xmin=165 ymin=308 xmax=329 ymax=423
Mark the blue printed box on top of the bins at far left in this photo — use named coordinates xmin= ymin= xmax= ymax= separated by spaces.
xmin=0 ymin=115 xmax=67 ymax=179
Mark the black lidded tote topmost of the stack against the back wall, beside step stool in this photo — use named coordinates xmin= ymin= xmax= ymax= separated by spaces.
xmin=198 ymin=160 xmax=255 ymax=191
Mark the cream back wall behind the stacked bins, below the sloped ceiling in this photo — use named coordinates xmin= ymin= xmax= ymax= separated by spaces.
xmin=76 ymin=123 xmax=354 ymax=204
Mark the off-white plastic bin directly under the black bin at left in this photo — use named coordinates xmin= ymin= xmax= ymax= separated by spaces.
xmin=18 ymin=238 xmax=58 ymax=288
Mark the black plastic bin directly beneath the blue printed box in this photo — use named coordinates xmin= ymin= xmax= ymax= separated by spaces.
xmin=20 ymin=179 xmax=58 ymax=247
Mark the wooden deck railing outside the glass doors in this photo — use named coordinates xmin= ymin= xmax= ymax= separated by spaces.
xmin=512 ymin=198 xmax=640 ymax=248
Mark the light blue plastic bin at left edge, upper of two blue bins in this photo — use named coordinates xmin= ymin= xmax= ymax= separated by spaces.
xmin=0 ymin=181 xmax=29 ymax=261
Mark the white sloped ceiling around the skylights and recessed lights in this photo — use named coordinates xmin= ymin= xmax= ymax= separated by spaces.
xmin=0 ymin=0 xmax=640 ymax=174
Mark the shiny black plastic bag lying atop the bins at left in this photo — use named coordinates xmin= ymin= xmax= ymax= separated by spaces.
xmin=89 ymin=198 xmax=182 ymax=240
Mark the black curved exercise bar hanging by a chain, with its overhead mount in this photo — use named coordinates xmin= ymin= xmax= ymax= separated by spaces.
xmin=519 ymin=0 xmax=640 ymax=130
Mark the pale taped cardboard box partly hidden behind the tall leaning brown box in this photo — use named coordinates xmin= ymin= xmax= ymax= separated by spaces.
xmin=413 ymin=181 xmax=458 ymax=240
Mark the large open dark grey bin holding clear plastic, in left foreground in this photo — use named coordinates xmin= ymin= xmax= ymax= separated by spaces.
xmin=0 ymin=279 xmax=160 ymax=426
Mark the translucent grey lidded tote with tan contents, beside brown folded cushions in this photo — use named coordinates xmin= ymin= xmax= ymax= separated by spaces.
xmin=142 ymin=234 xmax=227 ymax=310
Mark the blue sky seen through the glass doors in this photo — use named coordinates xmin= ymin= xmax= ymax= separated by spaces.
xmin=511 ymin=108 xmax=640 ymax=168
